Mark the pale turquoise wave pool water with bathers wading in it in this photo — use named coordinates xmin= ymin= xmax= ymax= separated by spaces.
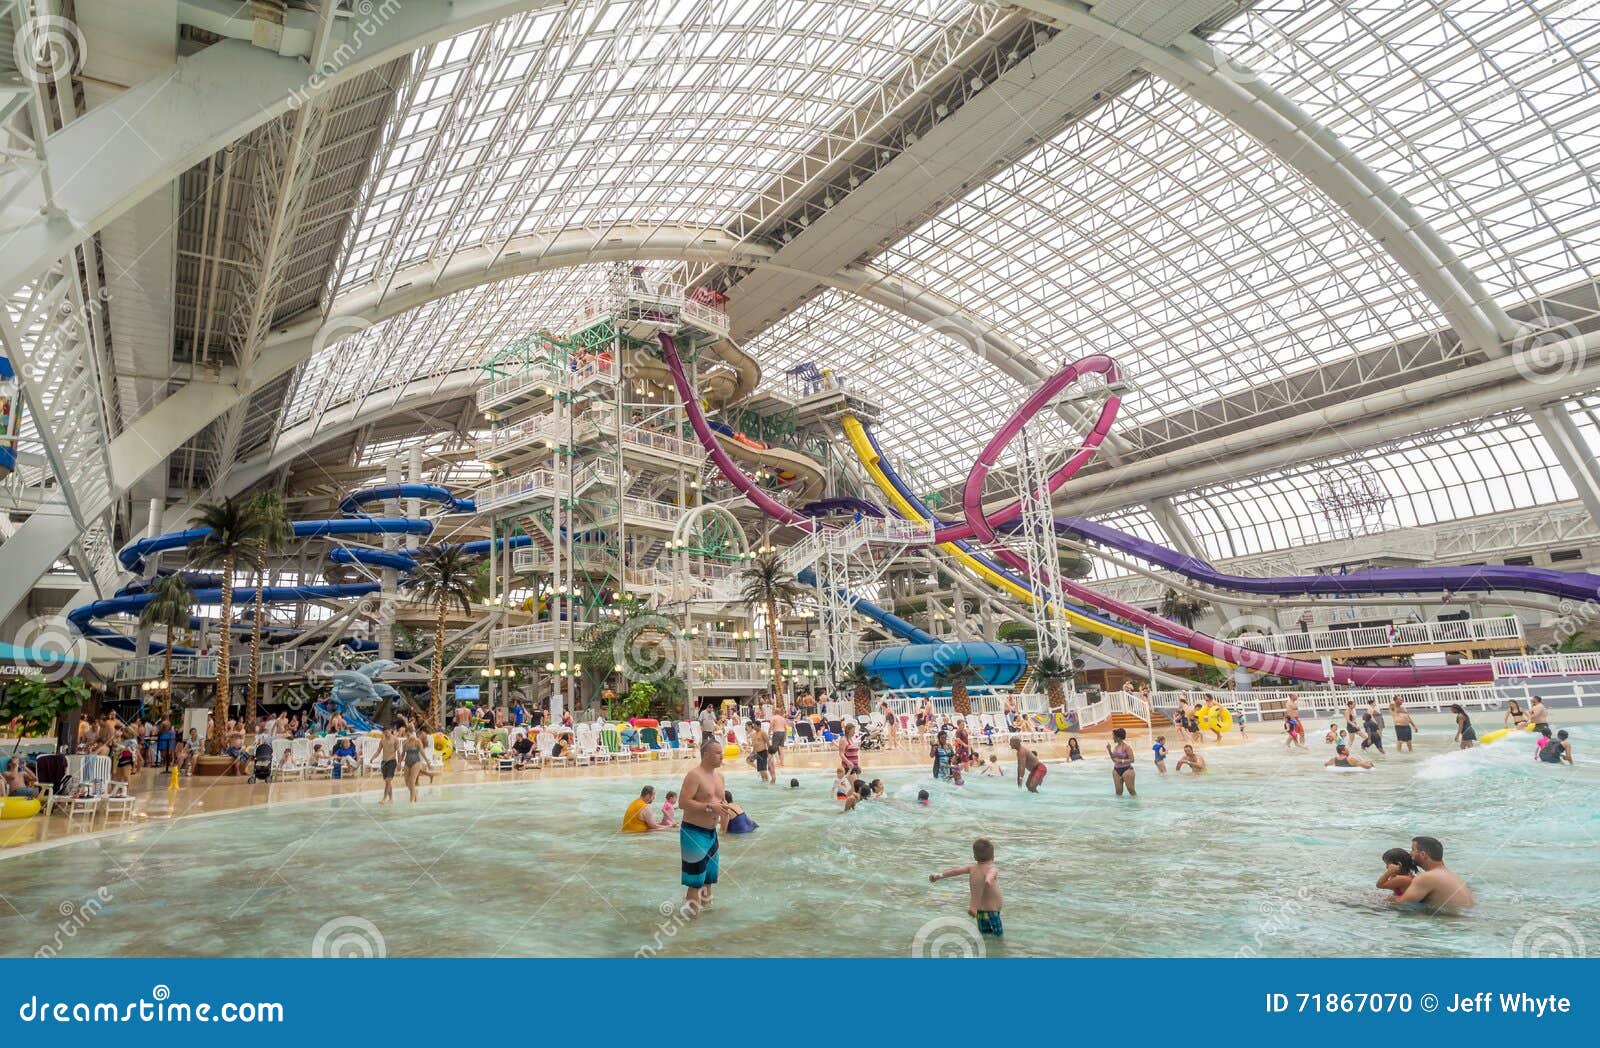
xmin=0 ymin=715 xmax=1600 ymax=957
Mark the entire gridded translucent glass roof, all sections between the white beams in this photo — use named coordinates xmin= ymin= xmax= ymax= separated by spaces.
xmin=262 ymin=0 xmax=1600 ymax=569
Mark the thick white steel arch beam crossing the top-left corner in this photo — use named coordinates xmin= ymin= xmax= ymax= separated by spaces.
xmin=0 ymin=0 xmax=565 ymax=296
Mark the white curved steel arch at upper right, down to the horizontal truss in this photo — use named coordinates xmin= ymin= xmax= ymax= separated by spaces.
xmin=1013 ymin=0 xmax=1518 ymax=355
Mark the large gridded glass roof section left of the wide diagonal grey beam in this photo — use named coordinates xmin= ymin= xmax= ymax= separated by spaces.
xmin=338 ymin=0 xmax=974 ymax=290
